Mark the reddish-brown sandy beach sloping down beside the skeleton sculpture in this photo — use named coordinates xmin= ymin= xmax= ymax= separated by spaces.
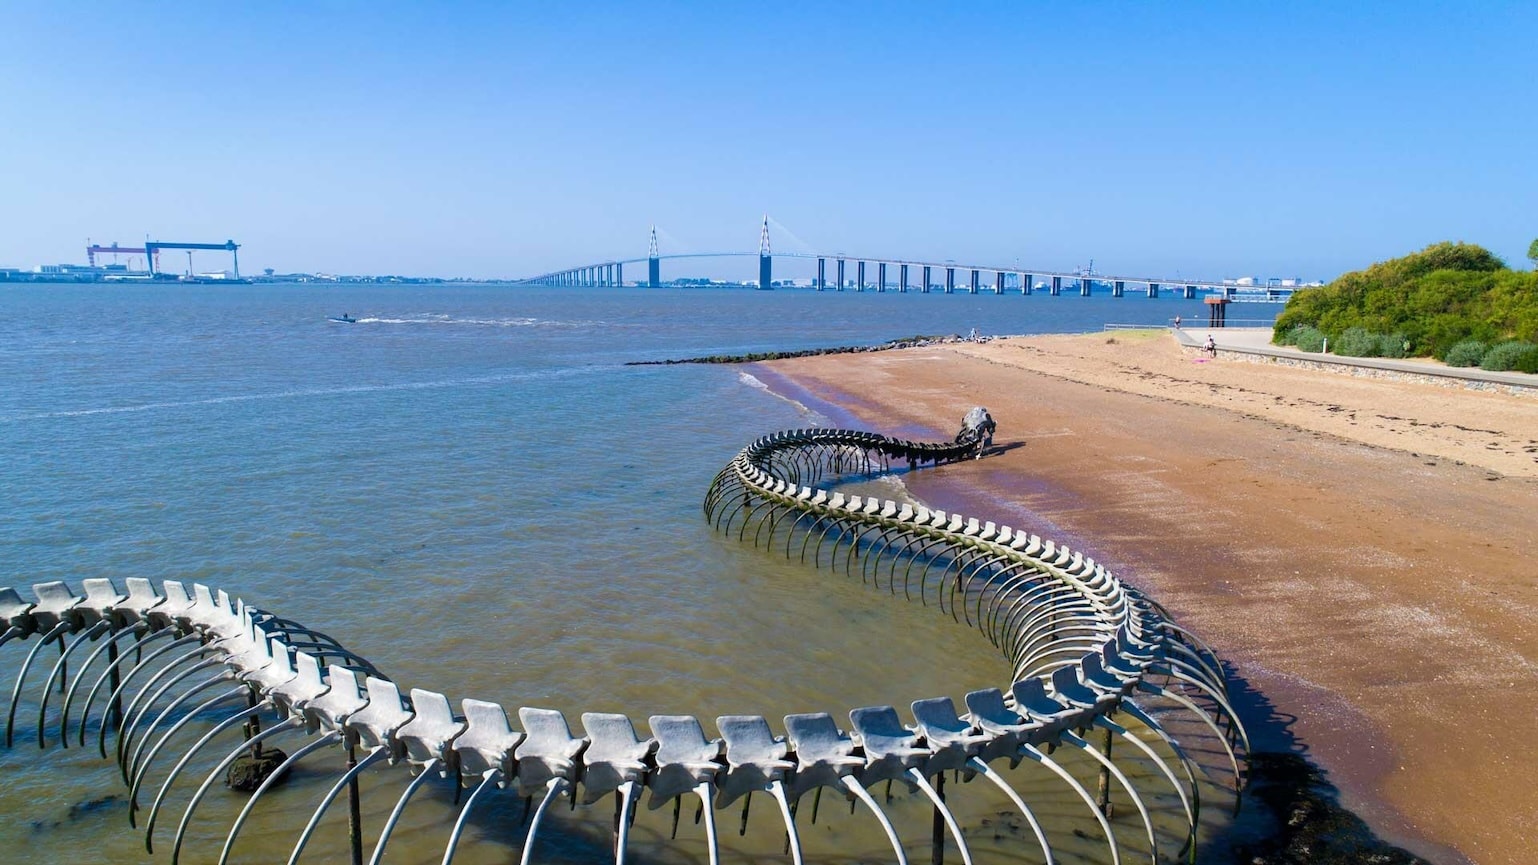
xmin=766 ymin=332 xmax=1538 ymax=865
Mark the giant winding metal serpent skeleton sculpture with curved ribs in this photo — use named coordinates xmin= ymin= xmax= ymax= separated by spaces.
xmin=0 ymin=409 xmax=1247 ymax=865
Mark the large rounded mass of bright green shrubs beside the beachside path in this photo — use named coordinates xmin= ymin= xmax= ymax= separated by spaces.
xmin=1273 ymin=243 xmax=1538 ymax=360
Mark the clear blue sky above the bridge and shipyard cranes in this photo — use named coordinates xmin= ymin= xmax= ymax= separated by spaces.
xmin=0 ymin=2 xmax=1538 ymax=279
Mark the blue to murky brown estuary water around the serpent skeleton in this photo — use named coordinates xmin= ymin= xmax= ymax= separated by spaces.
xmin=0 ymin=285 xmax=1236 ymax=863
